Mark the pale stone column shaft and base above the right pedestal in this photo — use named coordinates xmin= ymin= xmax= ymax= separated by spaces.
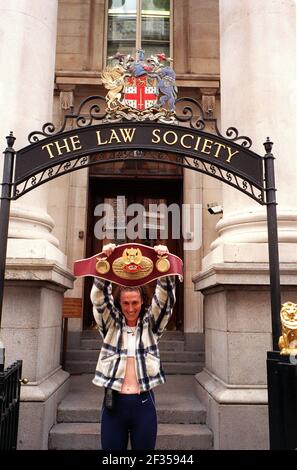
xmin=213 ymin=0 xmax=297 ymax=247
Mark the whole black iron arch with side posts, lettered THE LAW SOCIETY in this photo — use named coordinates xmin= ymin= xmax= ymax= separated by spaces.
xmin=0 ymin=96 xmax=280 ymax=348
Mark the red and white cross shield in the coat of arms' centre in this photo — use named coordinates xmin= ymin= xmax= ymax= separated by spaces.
xmin=124 ymin=75 xmax=158 ymax=111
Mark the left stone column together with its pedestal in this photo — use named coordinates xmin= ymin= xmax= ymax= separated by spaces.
xmin=0 ymin=0 xmax=73 ymax=449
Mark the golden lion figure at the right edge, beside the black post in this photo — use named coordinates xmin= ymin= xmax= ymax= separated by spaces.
xmin=278 ymin=302 xmax=297 ymax=354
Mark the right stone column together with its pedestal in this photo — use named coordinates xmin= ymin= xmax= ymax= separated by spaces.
xmin=195 ymin=0 xmax=297 ymax=449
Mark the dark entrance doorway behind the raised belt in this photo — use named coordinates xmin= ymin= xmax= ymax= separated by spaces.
xmin=84 ymin=177 xmax=183 ymax=330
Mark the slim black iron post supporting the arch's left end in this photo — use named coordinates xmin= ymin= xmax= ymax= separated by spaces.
xmin=0 ymin=132 xmax=15 ymax=371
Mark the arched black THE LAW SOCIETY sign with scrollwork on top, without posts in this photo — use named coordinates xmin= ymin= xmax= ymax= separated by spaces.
xmin=12 ymin=96 xmax=265 ymax=204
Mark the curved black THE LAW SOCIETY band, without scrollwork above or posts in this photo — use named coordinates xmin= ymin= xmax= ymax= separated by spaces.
xmin=14 ymin=122 xmax=264 ymax=203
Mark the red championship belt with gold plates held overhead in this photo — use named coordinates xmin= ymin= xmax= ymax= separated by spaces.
xmin=74 ymin=243 xmax=183 ymax=287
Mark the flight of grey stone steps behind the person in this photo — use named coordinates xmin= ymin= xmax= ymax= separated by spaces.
xmin=54 ymin=330 xmax=212 ymax=450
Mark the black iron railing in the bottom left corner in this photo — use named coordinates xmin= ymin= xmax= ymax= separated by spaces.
xmin=0 ymin=361 xmax=22 ymax=450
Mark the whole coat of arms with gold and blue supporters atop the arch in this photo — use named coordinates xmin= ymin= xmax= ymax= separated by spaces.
xmin=102 ymin=49 xmax=177 ymax=114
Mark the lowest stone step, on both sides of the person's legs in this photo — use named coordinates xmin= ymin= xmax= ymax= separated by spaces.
xmin=49 ymin=423 xmax=212 ymax=450
